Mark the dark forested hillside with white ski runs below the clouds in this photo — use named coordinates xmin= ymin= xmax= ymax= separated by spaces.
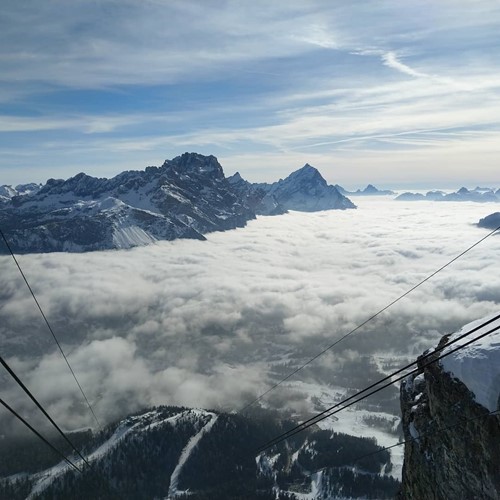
xmin=0 ymin=407 xmax=399 ymax=500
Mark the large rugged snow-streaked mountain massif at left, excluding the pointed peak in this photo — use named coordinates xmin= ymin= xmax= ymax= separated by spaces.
xmin=0 ymin=153 xmax=254 ymax=252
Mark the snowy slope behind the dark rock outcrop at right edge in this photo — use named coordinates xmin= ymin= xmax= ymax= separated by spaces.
xmin=440 ymin=313 xmax=500 ymax=411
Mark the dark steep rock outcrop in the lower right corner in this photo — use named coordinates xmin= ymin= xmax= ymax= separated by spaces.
xmin=399 ymin=336 xmax=500 ymax=500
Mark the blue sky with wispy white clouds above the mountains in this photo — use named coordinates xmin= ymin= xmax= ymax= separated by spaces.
xmin=0 ymin=0 xmax=500 ymax=188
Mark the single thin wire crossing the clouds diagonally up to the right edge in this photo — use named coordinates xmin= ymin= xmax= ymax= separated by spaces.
xmin=238 ymin=226 xmax=500 ymax=413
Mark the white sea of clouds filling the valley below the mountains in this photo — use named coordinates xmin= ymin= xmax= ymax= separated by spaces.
xmin=0 ymin=197 xmax=500 ymax=428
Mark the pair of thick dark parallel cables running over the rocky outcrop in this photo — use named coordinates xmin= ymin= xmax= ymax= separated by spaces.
xmin=256 ymin=315 xmax=500 ymax=453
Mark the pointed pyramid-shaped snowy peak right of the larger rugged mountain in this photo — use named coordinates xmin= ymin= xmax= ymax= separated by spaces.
xmin=228 ymin=164 xmax=356 ymax=214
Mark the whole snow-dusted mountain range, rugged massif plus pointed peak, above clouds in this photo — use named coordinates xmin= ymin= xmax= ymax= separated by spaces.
xmin=0 ymin=153 xmax=356 ymax=253
